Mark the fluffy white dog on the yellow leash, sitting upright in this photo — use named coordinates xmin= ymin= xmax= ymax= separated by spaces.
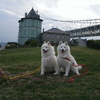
xmin=41 ymin=42 xmax=58 ymax=75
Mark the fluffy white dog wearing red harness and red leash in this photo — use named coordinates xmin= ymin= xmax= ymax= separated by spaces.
xmin=57 ymin=41 xmax=81 ymax=76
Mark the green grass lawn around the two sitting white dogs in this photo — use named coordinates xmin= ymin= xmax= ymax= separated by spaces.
xmin=0 ymin=47 xmax=100 ymax=100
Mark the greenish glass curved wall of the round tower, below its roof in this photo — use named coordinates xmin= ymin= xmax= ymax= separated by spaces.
xmin=18 ymin=18 xmax=41 ymax=45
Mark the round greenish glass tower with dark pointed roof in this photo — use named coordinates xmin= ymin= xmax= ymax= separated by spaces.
xmin=18 ymin=8 xmax=43 ymax=45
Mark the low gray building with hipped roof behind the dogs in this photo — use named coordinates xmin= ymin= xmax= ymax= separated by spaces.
xmin=41 ymin=28 xmax=70 ymax=44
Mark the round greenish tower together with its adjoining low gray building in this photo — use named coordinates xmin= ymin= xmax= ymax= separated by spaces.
xmin=18 ymin=8 xmax=70 ymax=45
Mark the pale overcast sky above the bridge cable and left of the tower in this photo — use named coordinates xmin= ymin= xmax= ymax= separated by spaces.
xmin=0 ymin=0 xmax=100 ymax=42
